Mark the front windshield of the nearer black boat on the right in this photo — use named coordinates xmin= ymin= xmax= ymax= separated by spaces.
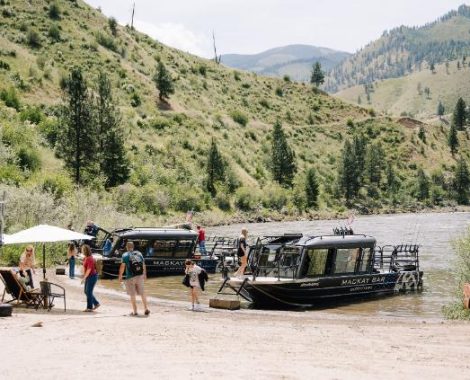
xmin=253 ymin=246 xmax=300 ymax=278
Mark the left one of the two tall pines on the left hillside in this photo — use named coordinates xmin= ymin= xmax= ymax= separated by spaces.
xmin=56 ymin=67 xmax=98 ymax=184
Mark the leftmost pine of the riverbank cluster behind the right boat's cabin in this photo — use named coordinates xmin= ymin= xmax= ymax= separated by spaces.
xmin=338 ymin=140 xmax=360 ymax=203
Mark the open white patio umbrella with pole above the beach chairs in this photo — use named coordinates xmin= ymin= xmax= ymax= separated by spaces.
xmin=3 ymin=224 xmax=95 ymax=278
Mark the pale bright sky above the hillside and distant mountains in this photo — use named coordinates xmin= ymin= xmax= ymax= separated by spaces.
xmin=85 ymin=0 xmax=463 ymax=58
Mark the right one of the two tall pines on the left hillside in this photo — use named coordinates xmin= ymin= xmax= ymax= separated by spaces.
xmin=95 ymin=72 xmax=130 ymax=188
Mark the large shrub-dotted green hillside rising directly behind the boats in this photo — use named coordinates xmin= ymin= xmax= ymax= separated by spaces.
xmin=0 ymin=0 xmax=469 ymax=235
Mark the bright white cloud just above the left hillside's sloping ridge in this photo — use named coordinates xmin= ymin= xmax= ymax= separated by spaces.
xmin=134 ymin=20 xmax=211 ymax=57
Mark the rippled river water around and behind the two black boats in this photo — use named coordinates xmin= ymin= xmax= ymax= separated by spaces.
xmin=101 ymin=213 xmax=470 ymax=318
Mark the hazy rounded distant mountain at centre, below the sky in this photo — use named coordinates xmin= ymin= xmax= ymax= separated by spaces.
xmin=222 ymin=45 xmax=351 ymax=81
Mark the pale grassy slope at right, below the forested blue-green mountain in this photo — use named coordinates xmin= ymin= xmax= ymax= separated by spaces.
xmin=335 ymin=59 xmax=470 ymax=120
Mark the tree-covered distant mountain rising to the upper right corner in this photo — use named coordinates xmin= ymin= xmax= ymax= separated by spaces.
xmin=324 ymin=5 xmax=470 ymax=92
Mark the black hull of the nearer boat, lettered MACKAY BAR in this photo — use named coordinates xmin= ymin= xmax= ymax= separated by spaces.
xmin=242 ymin=273 xmax=399 ymax=308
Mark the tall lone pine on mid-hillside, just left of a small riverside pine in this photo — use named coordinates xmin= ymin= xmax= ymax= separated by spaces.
xmin=271 ymin=121 xmax=297 ymax=187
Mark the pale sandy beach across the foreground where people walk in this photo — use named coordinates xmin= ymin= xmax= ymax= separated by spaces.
xmin=0 ymin=275 xmax=470 ymax=379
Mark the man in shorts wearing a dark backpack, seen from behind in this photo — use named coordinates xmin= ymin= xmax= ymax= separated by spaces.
xmin=119 ymin=241 xmax=150 ymax=316
